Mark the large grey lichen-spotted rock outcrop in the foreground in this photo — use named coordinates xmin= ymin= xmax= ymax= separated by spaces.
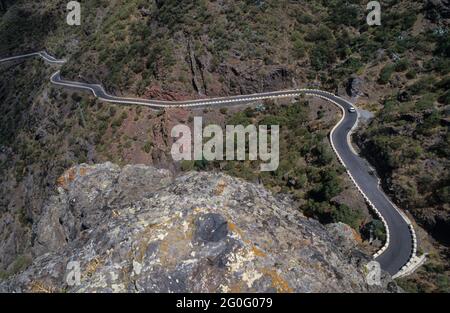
xmin=0 ymin=163 xmax=395 ymax=292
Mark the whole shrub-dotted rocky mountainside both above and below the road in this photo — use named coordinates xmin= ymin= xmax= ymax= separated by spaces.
xmin=0 ymin=0 xmax=450 ymax=291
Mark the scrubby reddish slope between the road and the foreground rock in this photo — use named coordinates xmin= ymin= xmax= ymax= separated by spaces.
xmin=0 ymin=59 xmax=383 ymax=279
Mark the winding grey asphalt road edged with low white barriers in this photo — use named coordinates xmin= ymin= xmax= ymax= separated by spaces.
xmin=0 ymin=51 xmax=415 ymax=275
